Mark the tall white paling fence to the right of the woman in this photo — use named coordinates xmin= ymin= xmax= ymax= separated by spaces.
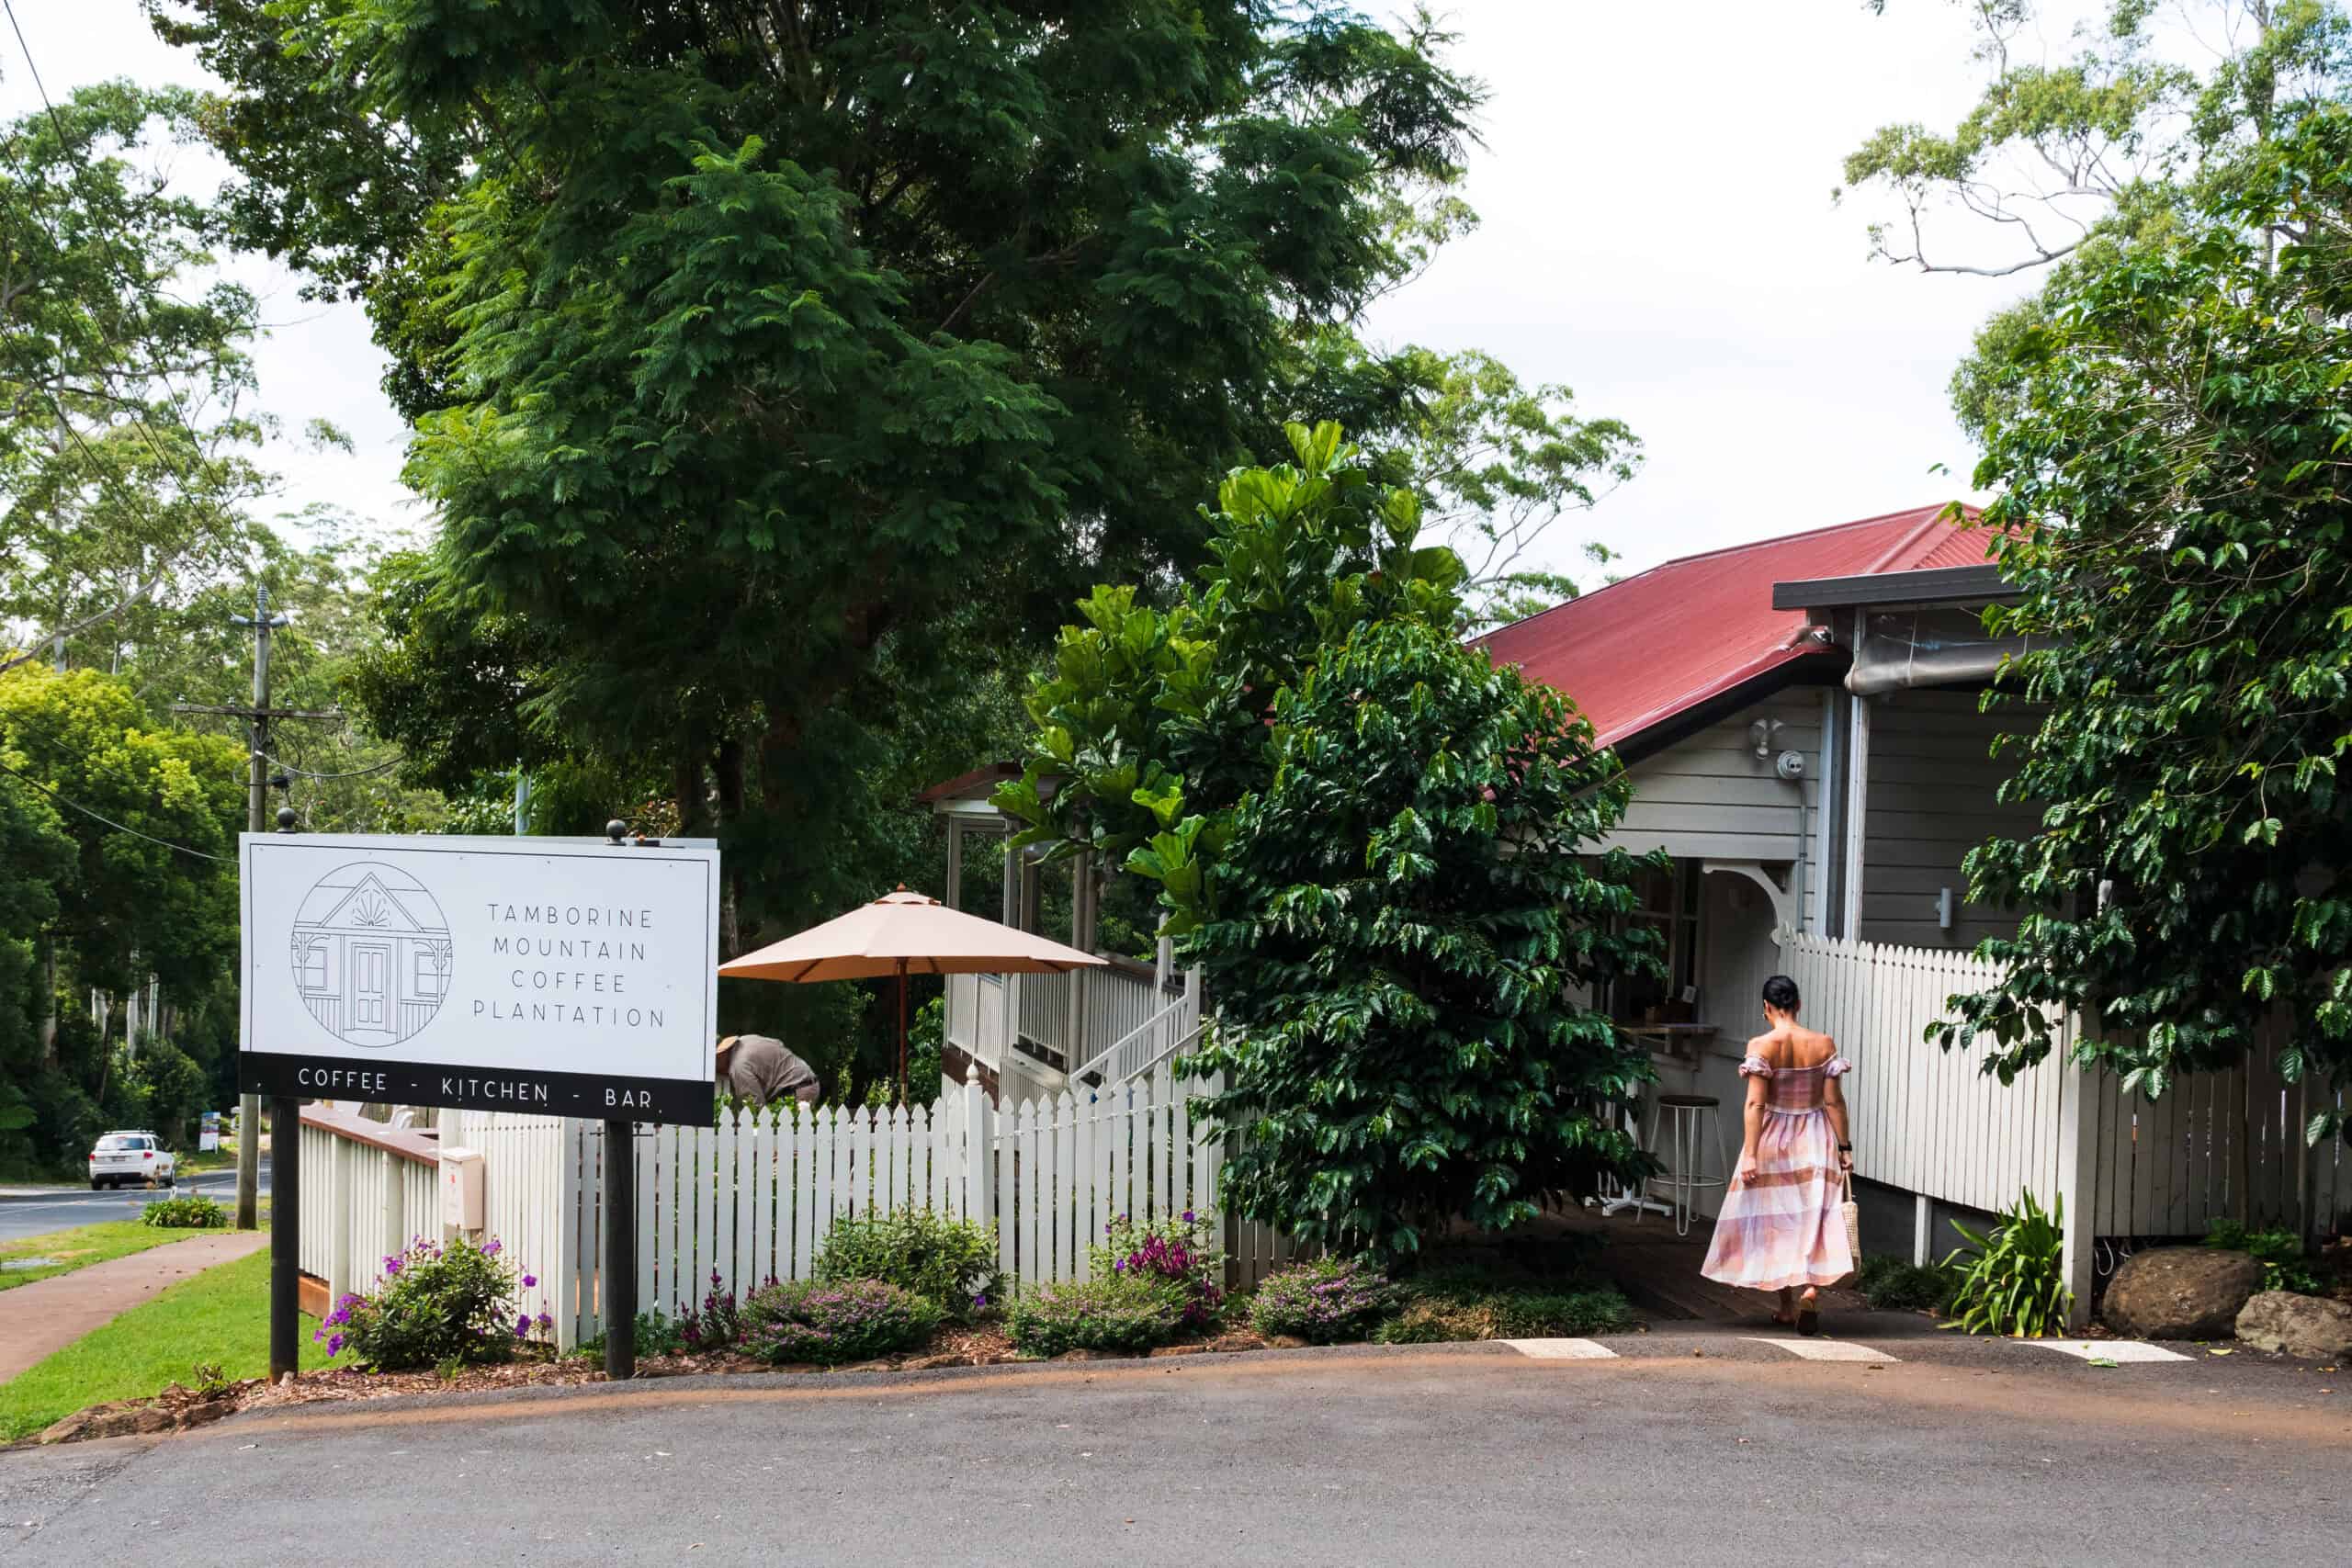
xmin=1781 ymin=931 xmax=2352 ymax=1307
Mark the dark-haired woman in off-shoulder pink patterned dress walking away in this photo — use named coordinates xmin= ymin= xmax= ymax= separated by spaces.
xmin=1701 ymin=976 xmax=1853 ymax=1333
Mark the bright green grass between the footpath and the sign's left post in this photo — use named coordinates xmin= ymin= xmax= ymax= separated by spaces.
xmin=0 ymin=1232 xmax=327 ymax=1441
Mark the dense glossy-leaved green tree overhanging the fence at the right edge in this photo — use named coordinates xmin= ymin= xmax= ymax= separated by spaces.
xmin=1918 ymin=106 xmax=2352 ymax=1140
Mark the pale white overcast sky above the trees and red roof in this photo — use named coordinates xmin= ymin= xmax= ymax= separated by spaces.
xmin=0 ymin=0 xmax=2067 ymax=583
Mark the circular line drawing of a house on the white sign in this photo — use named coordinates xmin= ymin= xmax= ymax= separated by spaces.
xmin=291 ymin=861 xmax=452 ymax=1048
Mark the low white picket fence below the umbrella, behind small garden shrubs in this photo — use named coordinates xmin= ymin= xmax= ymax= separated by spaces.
xmin=442 ymin=1067 xmax=1291 ymax=1345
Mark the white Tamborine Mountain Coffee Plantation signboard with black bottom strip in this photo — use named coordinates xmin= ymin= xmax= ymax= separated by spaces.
xmin=240 ymin=835 xmax=719 ymax=1122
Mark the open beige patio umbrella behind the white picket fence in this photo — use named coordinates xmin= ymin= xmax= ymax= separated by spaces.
xmin=719 ymin=884 xmax=1103 ymax=1102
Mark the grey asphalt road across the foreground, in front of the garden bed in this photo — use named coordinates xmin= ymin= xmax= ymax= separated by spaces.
xmin=0 ymin=1336 xmax=2352 ymax=1568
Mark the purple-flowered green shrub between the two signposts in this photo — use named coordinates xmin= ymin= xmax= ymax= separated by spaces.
xmin=311 ymin=1239 xmax=555 ymax=1373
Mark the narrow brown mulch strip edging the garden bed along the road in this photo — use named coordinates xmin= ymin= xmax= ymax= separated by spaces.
xmin=30 ymin=1321 xmax=1284 ymax=1443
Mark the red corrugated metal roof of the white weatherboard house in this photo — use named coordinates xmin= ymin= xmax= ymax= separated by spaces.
xmin=1479 ymin=503 xmax=1987 ymax=745
